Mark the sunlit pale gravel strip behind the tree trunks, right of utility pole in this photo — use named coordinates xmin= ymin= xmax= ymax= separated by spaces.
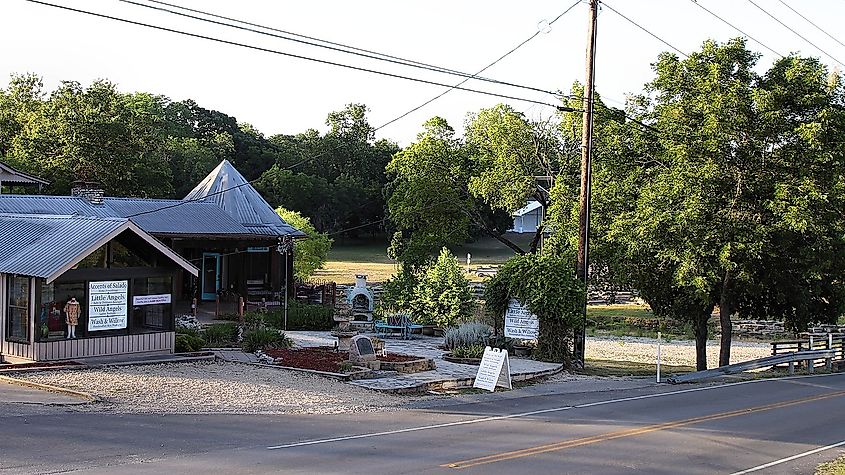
xmin=586 ymin=337 xmax=772 ymax=368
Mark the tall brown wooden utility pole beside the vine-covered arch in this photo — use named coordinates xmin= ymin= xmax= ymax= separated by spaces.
xmin=573 ymin=0 xmax=599 ymax=366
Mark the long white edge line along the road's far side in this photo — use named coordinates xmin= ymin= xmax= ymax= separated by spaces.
xmin=267 ymin=374 xmax=844 ymax=450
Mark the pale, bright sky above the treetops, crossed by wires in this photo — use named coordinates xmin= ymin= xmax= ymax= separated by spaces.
xmin=0 ymin=0 xmax=845 ymax=146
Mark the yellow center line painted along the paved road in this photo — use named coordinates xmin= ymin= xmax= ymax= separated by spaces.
xmin=441 ymin=391 xmax=845 ymax=469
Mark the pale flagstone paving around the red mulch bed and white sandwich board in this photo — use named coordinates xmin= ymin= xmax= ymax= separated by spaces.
xmin=286 ymin=331 xmax=561 ymax=392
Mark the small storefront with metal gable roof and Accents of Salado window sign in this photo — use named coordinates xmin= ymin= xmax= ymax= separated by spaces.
xmin=0 ymin=213 xmax=199 ymax=361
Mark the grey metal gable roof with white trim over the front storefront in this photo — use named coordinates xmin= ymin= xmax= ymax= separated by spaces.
xmin=0 ymin=213 xmax=199 ymax=283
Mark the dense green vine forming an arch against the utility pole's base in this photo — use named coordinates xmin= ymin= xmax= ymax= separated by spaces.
xmin=484 ymin=253 xmax=585 ymax=365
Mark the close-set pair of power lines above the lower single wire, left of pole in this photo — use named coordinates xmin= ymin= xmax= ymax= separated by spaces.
xmin=113 ymin=0 xmax=554 ymax=95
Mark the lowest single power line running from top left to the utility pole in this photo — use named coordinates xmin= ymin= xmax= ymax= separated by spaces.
xmin=26 ymin=0 xmax=555 ymax=107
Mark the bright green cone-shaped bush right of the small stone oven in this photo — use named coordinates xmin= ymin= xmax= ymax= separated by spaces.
xmin=416 ymin=247 xmax=475 ymax=328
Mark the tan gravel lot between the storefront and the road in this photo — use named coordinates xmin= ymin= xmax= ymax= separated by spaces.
xmin=15 ymin=362 xmax=409 ymax=414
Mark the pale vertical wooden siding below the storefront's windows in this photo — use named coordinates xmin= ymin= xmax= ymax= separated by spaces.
xmin=3 ymin=332 xmax=176 ymax=361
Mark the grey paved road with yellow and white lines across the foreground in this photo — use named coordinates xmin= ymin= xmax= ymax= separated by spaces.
xmin=0 ymin=375 xmax=845 ymax=474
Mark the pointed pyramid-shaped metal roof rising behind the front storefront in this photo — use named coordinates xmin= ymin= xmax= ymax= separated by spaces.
xmin=185 ymin=160 xmax=305 ymax=236
